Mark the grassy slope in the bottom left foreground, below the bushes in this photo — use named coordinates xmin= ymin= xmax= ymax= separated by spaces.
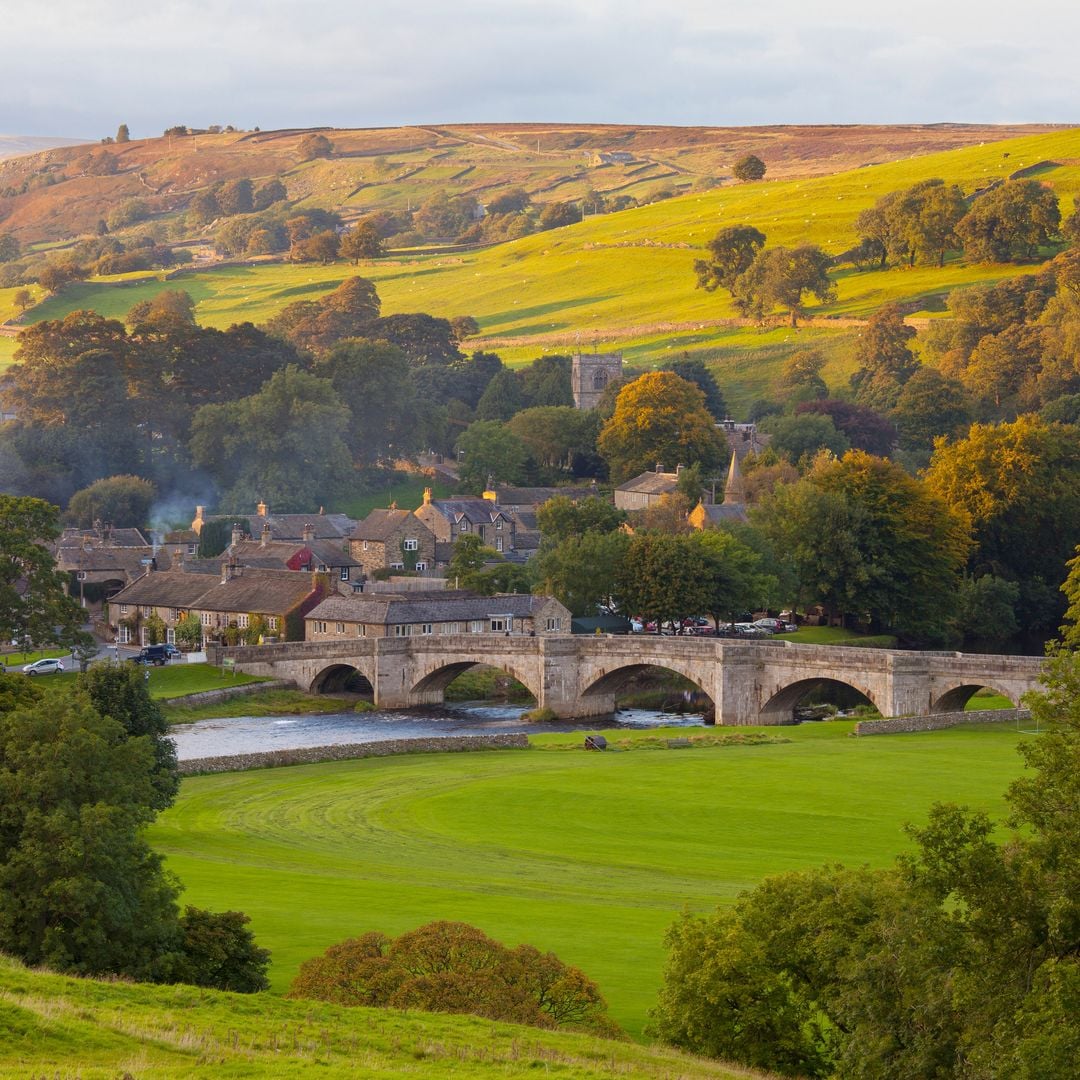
xmin=0 ymin=957 xmax=752 ymax=1080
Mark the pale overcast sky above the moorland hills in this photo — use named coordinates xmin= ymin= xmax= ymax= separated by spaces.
xmin=0 ymin=0 xmax=1080 ymax=138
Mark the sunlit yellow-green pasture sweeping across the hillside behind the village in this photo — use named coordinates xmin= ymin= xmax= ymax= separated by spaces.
xmin=10 ymin=131 xmax=1080 ymax=405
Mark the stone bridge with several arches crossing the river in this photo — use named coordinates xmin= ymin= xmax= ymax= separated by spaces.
xmin=207 ymin=634 xmax=1043 ymax=725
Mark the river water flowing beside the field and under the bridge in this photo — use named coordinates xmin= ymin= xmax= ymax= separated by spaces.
xmin=170 ymin=702 xmax=703 ymax=761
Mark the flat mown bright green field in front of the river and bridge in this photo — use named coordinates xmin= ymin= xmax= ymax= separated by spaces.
xmin=151 ymin=721 xmax=1021 ymax=1034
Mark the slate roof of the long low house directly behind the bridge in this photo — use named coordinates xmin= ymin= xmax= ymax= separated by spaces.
xmin=306 ymin=590 xmax=551 ymax=625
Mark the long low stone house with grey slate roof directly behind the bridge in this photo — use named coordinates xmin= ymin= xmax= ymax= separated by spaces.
xmin=306 ymin=590 xmax=570 ymax=642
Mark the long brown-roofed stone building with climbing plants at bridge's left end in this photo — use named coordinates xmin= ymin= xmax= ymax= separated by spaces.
xmin=109 ymin=563 xmax=330 ymax=645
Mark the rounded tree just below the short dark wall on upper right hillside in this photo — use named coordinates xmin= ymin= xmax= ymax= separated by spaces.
xmin=956 ymin=180 xmax=1062 ymax=262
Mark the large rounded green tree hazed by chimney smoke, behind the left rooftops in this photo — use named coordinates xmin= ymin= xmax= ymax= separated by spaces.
xmin=191 ymin=364 xmax=352 ymax=505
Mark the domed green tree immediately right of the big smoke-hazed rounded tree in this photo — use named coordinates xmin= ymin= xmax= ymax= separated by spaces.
xmin=312 ymin=338 xmax=422 ymax=463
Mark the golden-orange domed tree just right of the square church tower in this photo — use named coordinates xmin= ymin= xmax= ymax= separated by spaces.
xmin=596 ymin=372 xmax=727 ymax=483
